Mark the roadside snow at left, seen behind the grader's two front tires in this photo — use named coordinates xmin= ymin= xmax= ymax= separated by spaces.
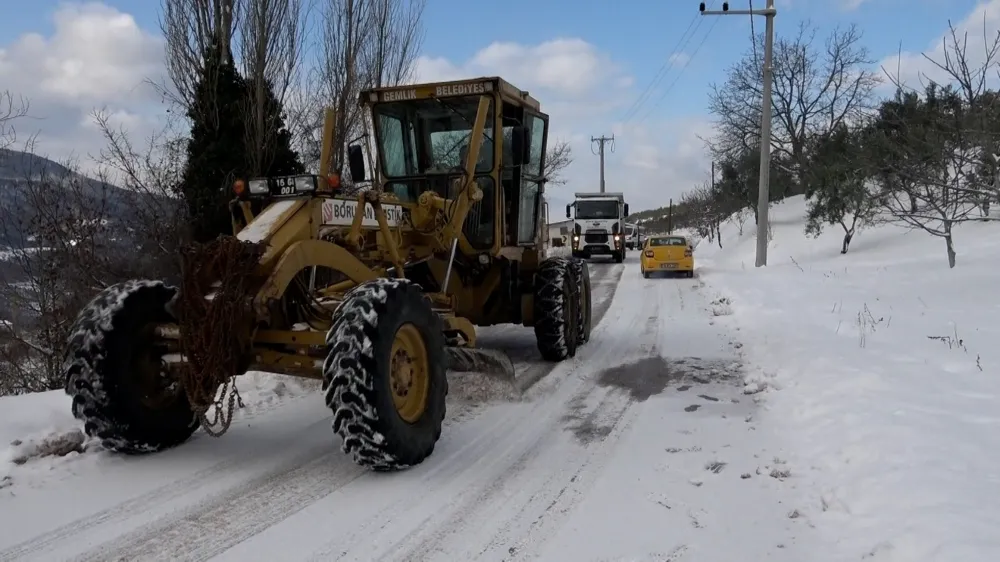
xmin=0 ymin=371 xmax=319 ymax=490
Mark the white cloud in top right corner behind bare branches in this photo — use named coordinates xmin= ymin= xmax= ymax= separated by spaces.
xmin=880 ymin=0 xmax=1000 ymax=93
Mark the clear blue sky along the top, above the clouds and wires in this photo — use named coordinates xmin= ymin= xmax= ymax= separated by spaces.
xmin=0 ymin=0 xmax=976 ymax=124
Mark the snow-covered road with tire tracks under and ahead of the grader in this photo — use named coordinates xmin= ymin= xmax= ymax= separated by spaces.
xmin=0 ymin=257 xmax=813 ymax=562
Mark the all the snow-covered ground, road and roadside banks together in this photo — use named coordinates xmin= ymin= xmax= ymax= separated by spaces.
xmin=0 ymin=202 xmax=1000 ymax=562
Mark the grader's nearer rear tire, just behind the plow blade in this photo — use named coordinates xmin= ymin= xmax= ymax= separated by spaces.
xmin=534 ymin=258 xmax=579 ymax=361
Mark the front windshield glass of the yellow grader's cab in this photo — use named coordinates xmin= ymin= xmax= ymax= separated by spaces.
xmin=374 ymin=96 xmax=493 ymax=178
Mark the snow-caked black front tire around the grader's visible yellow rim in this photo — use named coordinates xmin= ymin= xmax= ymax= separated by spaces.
xmin=323 ymin=278 xmax=448 ymax=472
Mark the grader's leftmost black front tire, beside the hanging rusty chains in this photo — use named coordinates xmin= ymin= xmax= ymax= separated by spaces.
xmin=63 ymin=280 xmax=199 ymax=454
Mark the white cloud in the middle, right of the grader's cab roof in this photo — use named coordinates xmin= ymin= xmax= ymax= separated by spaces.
xmin=416 ymin=38 xmax=711 ymax=214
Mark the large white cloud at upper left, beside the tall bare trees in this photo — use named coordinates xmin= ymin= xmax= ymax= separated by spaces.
xmin=0 ymin=3 xmax=164 ymax=165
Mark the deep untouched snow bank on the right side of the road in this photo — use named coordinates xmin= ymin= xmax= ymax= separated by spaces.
xmin=695 ymin=196 xmax=1000 ymax=562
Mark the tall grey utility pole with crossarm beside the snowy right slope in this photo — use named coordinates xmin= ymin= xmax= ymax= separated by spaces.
xmin=698 ymin=0 xmax=778 ymax=267
